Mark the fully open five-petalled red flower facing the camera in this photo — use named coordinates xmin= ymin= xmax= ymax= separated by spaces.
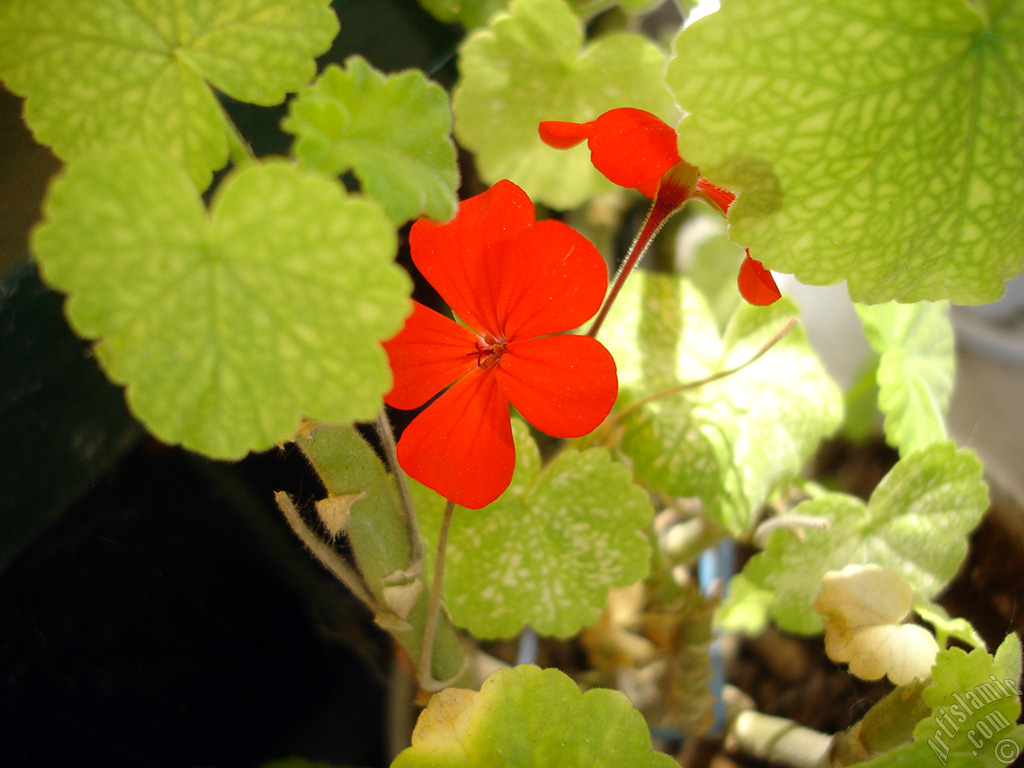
xmin=384 ymin=181 xmax=618 ymax=509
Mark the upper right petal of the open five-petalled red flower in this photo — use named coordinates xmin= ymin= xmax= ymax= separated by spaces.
xmin=497 ymin=221 xmax=608 ymax=341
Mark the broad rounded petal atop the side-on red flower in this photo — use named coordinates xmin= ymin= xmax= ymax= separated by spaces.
xmin=587 ymin=108 xmax=682 ymax=198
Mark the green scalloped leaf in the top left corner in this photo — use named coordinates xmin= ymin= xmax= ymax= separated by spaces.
xmin=0 ymin=0 xmax=338 ymax=188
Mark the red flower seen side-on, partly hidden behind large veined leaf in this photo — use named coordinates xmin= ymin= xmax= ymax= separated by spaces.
xmin=540 ymin=108 xmax=781 ymax=306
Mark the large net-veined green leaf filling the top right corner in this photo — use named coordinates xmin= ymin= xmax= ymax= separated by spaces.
xmin=668 ymin=0 xmax=1024 ymax=304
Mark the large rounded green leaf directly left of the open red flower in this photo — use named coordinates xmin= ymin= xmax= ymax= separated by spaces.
xmin=33 ymin=146 xmax=410 ymax=459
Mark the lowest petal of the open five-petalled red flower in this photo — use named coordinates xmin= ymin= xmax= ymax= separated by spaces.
xmin=398 ymin=369 xmax=515 ymax=509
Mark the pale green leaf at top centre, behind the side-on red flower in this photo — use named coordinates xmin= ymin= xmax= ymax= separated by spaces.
xmin=453 ymin=0 xmax=677 ymax=209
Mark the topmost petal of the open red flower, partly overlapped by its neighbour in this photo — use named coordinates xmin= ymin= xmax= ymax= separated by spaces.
xmin=409 ymin=180 xmax=534 ymax=336
